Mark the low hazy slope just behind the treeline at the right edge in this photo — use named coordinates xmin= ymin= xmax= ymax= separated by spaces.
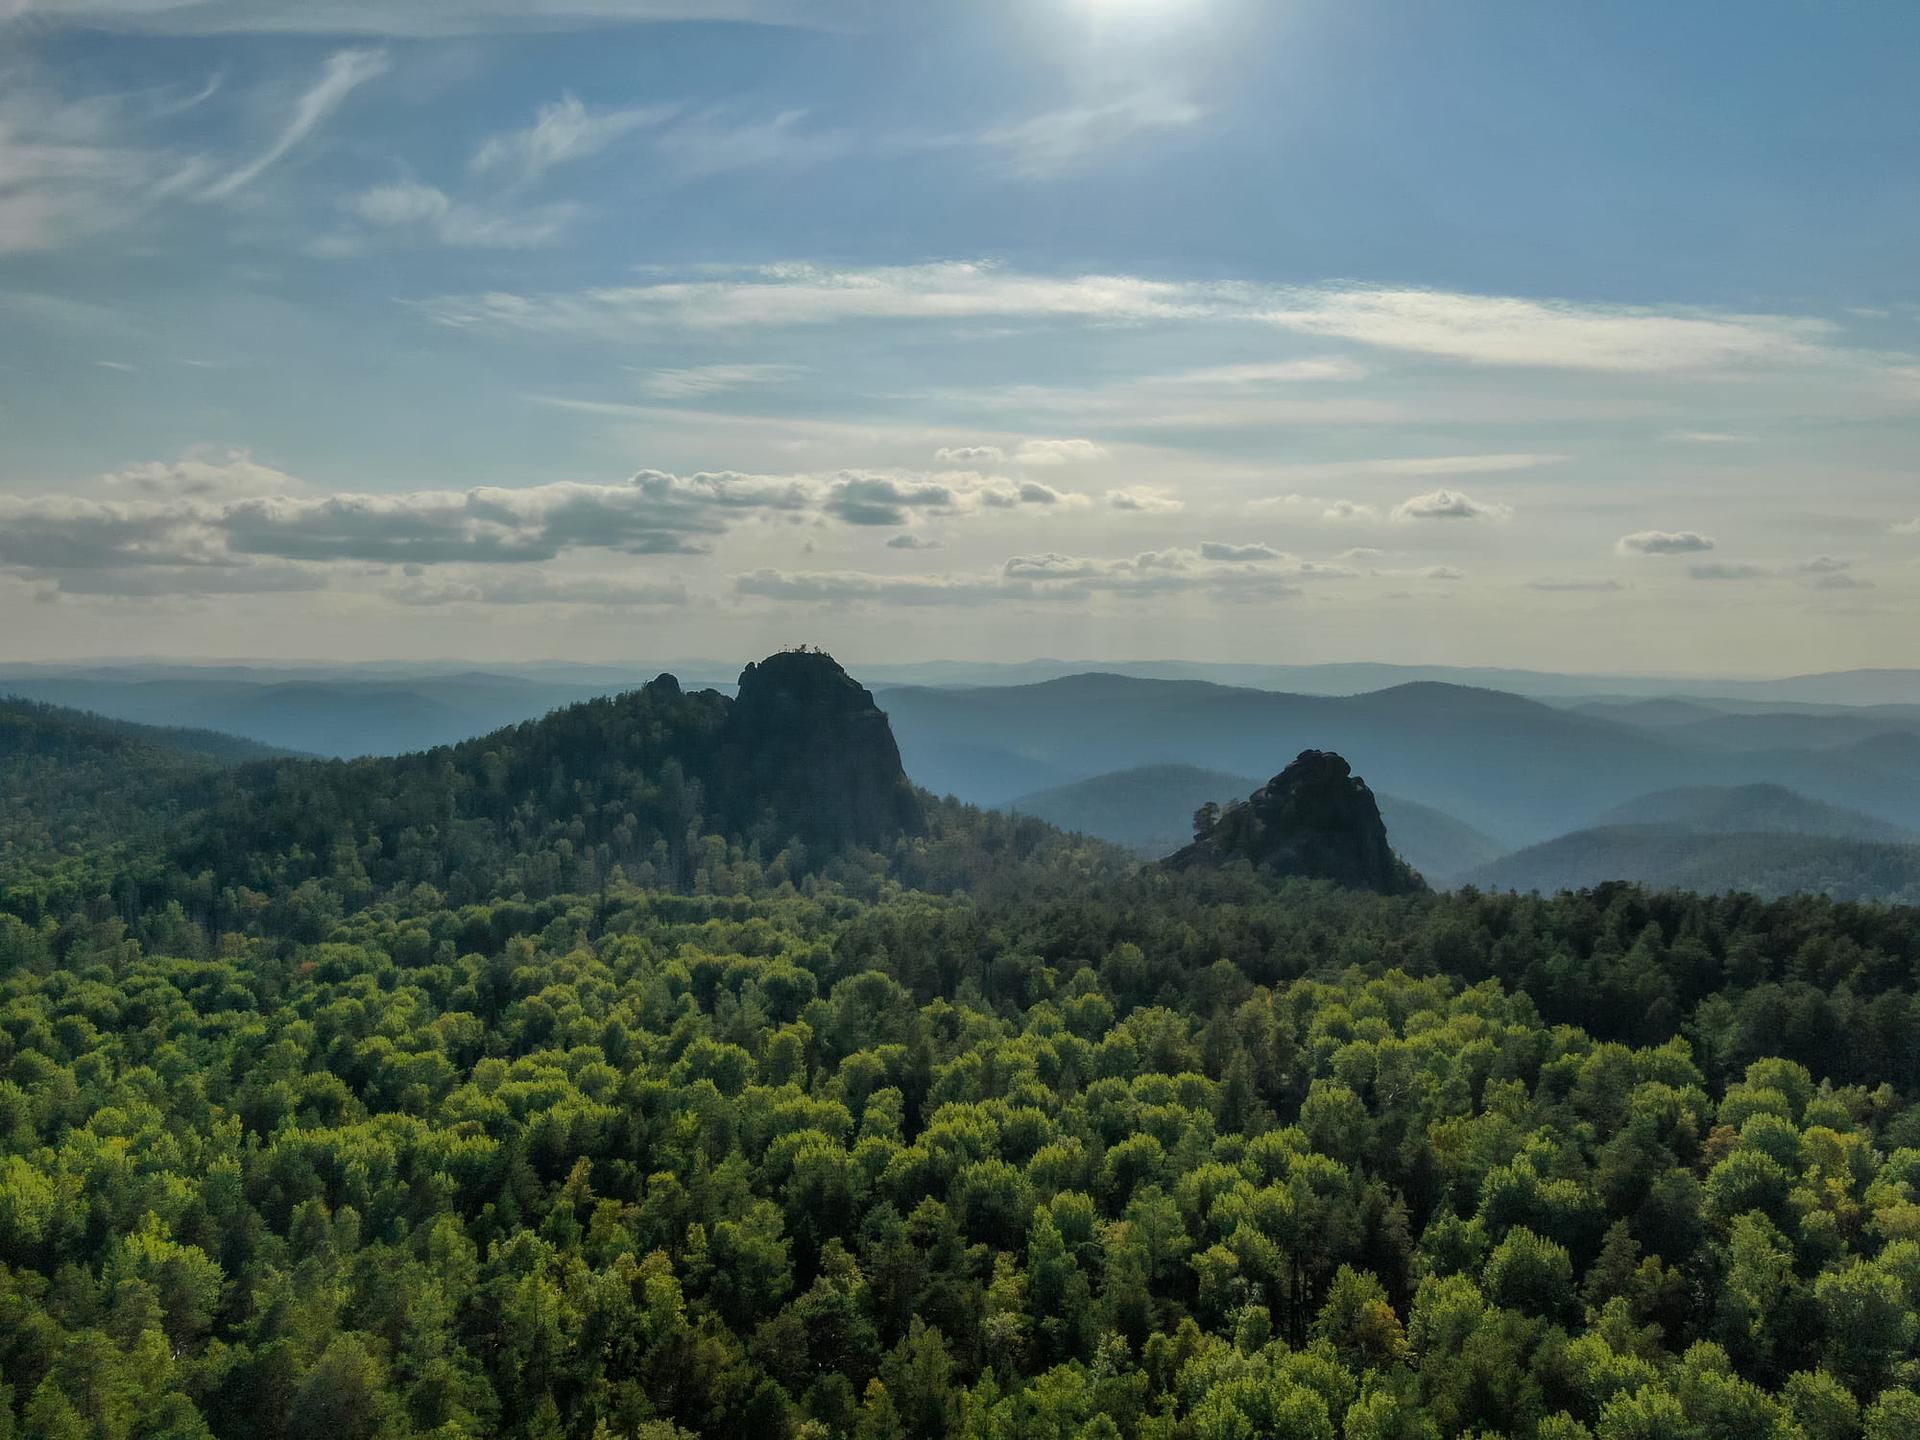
xmin=1463 ymin=826 xmax=1920 ymax=904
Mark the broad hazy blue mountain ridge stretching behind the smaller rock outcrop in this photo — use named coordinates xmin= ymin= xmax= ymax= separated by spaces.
xmin=879 ymin=674 xmax=1920 ymax=849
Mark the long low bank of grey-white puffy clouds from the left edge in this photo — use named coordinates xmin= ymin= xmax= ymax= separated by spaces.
xmin=0 ymin=447 xmax=1091 ymax=603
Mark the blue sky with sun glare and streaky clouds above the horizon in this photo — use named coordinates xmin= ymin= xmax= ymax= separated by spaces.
xmin=0 ymin=0 xmax=1920 ymax=676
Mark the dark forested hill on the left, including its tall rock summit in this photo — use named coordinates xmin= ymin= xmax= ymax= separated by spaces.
xmin=173 ymin=651 xmax=927 ymax=897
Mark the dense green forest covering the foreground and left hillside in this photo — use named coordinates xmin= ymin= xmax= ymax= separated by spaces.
xmin=0 ymin=660 xmax=1920 ymax=1440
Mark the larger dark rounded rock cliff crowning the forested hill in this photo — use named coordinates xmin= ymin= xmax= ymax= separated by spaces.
xmin=708 ymin=651 xmax=927 ymax=849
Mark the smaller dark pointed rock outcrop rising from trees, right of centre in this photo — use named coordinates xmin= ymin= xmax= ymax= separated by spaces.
xmin=1165 ymin=751 xmax=1425 ymax=895
